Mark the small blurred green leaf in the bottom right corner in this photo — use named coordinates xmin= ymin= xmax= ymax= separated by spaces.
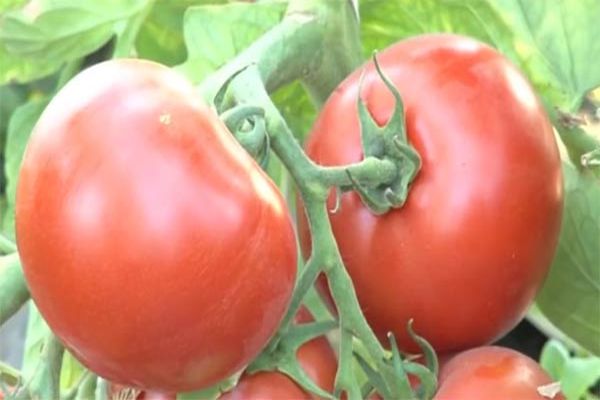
xmin=540 ymin=340 xmax=600 ymax=400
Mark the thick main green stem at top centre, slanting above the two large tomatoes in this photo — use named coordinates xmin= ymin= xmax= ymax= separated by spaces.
xmin=200 ymin=0 xmax=362 ymax=105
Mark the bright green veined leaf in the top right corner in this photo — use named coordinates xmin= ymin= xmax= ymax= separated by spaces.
xmin=490 ymin=0 xmax=600 ymax=111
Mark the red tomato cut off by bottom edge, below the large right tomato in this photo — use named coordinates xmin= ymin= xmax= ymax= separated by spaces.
xmin=434 ymin=346 xmax=564 ymax=400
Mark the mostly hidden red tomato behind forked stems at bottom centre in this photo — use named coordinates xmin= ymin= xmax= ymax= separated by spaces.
xmin=220 ymin=308 xmax=337 ymax=400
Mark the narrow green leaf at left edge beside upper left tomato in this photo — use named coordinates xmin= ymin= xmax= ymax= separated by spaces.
xmin=2 ymin=98 xmax=49 ymax=238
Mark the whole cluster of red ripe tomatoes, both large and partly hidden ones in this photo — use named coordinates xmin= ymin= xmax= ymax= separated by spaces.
xmin=16 ymin=35 xmax=562 ymax=399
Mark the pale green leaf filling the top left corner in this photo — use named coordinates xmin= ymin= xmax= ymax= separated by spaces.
xmin=0 ymin=0 xmax=149 ymax=83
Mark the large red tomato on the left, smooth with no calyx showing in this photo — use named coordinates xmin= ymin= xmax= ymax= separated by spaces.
xmin=16 ymin=60 xmax=297 ymax=393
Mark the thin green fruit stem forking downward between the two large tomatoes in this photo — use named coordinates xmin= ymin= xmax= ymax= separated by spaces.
xmin=225 ymin=68 xmax=402 ymax=397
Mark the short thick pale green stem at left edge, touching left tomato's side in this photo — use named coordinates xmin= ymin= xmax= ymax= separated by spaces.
xmin=0 ymin=253 xmax=29 ymax=325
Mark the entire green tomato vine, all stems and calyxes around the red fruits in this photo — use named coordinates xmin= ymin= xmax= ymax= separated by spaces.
xmin=0 ymin=0 xmax=600 ymax=400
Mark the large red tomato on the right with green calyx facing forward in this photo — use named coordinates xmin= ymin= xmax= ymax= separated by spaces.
xmin=299 ymin=34 xmax=563 ymax=352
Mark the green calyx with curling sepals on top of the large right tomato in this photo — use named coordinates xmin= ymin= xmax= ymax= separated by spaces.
xmin=346 ymin=54 xmax=421 ymax=214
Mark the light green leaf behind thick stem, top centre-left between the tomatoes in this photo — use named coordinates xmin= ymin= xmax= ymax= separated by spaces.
xmin=176 ymin=1 xmax=286 ymax=83
